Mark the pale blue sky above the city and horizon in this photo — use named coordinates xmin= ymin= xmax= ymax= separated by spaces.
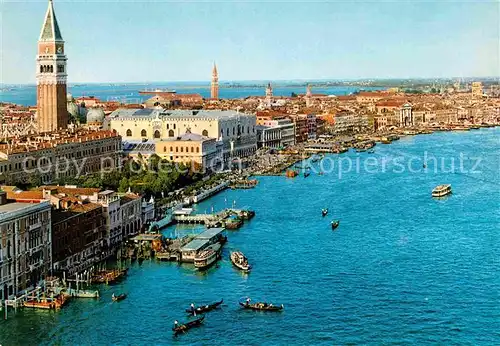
xmin=0 ymin=0 xmax=500 ymax=84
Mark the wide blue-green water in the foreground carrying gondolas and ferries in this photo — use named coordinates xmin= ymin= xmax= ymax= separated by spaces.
xmin=0 ymin=129 xmax=500 ymax=345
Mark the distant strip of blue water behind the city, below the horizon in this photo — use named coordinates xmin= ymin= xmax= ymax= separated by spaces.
xmin=0 ymin=82 xmax=380 ymax=106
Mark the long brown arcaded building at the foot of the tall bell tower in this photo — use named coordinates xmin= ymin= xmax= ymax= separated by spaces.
xmin=0 ymin=131 xmax=121 ymax=185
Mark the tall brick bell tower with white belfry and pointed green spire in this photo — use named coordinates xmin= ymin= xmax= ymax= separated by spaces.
xmin=36 ymin=0 xmax=69 ymax=132
